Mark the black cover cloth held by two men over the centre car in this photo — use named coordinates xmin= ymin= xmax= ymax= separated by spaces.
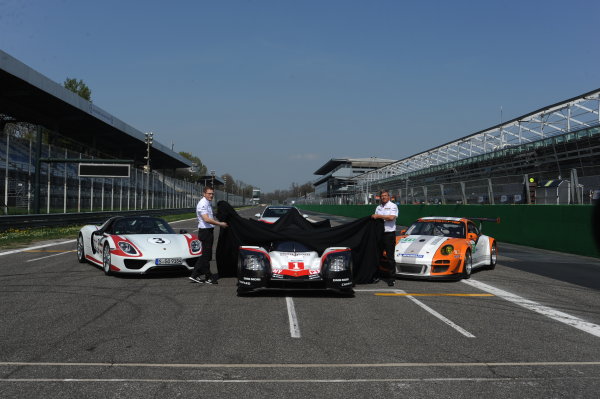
xmin=216 ymin=201 xmax=383 ymax=284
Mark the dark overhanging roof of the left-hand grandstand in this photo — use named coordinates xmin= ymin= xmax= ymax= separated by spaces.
xmin=0 ymin=50 xmax=191 ymax=169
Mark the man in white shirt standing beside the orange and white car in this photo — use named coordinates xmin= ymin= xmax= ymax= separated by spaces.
xmin=371 ymin=190 xmax=398 ymax=287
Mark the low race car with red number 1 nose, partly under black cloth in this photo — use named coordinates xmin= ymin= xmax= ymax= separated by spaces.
xmin=238 ymin=241 xmax=353 ymax=295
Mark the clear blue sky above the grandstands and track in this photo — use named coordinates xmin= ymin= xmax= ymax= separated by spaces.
xmin=0 ymin=0 xmax=600 ymax=191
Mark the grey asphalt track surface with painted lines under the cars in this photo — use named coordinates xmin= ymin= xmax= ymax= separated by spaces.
xmin=0 ymin=209 xmax=600 ymax=398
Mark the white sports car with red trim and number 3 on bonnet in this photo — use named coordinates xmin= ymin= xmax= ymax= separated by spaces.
xmin=77 ymin=216 xmax=202 ymax=275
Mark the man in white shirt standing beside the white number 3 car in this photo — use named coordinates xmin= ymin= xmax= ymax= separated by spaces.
xmin=190 ymin=186 xmax=227 ymax=284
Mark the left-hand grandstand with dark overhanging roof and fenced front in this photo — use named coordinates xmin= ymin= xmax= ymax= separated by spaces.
xmin=0 ymin=51 xmax=242 ymax=214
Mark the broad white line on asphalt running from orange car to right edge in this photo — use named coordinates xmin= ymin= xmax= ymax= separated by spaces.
xmin=462 ymin=280 xmax=600 ymax=337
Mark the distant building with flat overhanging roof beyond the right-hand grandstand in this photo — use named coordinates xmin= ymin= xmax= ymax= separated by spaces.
xmin=313 ymin=157 xmax=397 ymax=198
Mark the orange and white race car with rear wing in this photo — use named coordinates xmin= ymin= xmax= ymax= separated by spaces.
xmin=395 ymin=216 xmax=500 ymax=280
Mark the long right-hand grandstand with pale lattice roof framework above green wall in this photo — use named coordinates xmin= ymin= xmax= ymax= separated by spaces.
xmin=319 ymin=89 xmax=600 ymax=204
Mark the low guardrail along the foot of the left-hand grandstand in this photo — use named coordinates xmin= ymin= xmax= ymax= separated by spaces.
xmin=0 ymin=208 xmax=196 ymax=231
